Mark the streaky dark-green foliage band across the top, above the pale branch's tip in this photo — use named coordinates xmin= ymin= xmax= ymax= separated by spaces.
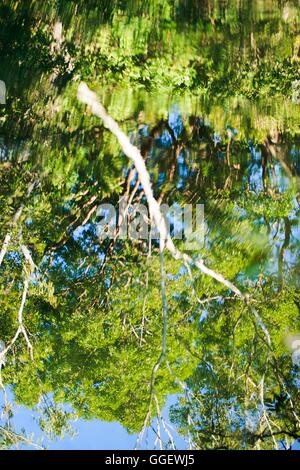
xmin=0 ymin=0 xmax=299 ymax=125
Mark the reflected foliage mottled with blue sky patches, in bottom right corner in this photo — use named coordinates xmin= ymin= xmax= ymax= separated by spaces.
xmin=172 ymin=282 xmax=300 ymax=449
